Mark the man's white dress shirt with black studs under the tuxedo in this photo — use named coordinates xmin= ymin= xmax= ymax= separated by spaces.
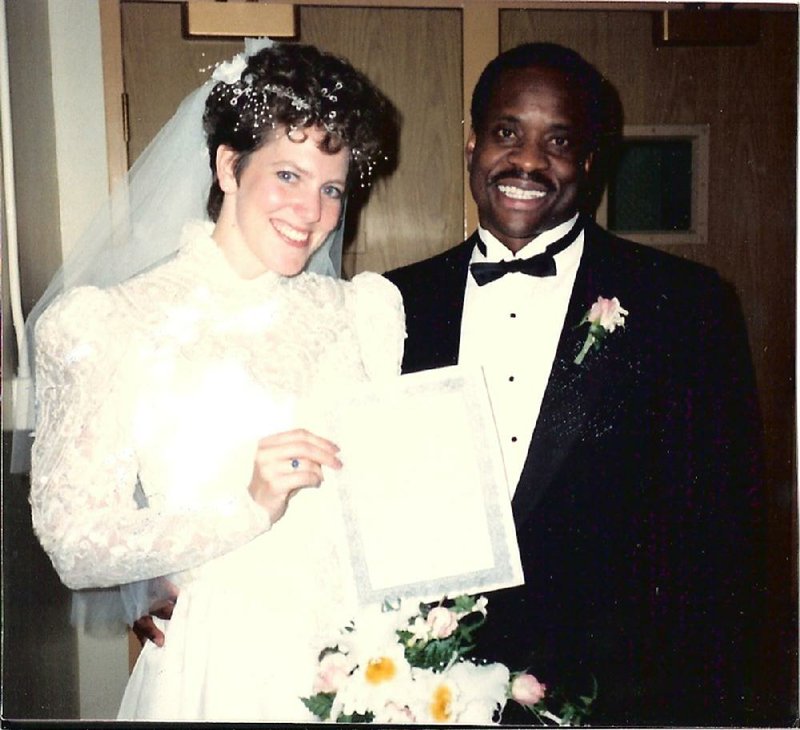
xmin=458 ymin=215 xmax=583 ymax=496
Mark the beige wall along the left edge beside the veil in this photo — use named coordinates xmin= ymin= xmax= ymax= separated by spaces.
xmin=3 ymin=0 xmax=127 ymax=718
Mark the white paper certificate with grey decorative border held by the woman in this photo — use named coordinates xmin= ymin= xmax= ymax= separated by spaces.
xmin=330 ymin=366 xmax=524 ymax=604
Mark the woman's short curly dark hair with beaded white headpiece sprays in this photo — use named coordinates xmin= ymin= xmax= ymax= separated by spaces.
xmin=203 ymin=43 xmax=397 ymax=221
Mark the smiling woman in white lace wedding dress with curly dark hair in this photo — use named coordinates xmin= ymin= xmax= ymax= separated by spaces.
xmin=31 ymin=38 xmax=404 ymax=721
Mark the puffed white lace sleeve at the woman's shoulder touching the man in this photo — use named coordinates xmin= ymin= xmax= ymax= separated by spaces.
xmin=351 ymin=272 xmax=406 ymax=379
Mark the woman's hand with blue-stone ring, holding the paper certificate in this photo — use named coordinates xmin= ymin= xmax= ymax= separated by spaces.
xmin=248 ymin=428 xmax=342 ymax=523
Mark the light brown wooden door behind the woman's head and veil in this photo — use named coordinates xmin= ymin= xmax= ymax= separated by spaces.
xmin=121 ymin=2 xmax=464 ymax=275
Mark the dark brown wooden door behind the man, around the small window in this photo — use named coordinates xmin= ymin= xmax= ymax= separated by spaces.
xmin=500 ymin=7 xmax=797 ymax=702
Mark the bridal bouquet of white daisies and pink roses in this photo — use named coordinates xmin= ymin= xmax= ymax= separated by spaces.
xmin=302 ymin=596 xmax=594 ymax=725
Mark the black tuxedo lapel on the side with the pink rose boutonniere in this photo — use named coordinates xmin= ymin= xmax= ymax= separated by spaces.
xmin=512 ymin=226 xmax=632 ymax=525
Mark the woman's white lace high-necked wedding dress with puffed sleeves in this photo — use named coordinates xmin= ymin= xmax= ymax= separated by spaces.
xmin=31 ymin=222 xmax=404 ymax=722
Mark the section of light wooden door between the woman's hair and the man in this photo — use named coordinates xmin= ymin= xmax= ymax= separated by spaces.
xmin=300 ymin=7 xmax=464 ymax=271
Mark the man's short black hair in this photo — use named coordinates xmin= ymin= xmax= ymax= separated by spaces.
xmin=470 ymin=43 xmax=620 ymax=152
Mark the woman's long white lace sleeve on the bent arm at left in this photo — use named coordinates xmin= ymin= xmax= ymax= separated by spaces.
xmin=30 ymin=288 xmax=270 ymax=589
